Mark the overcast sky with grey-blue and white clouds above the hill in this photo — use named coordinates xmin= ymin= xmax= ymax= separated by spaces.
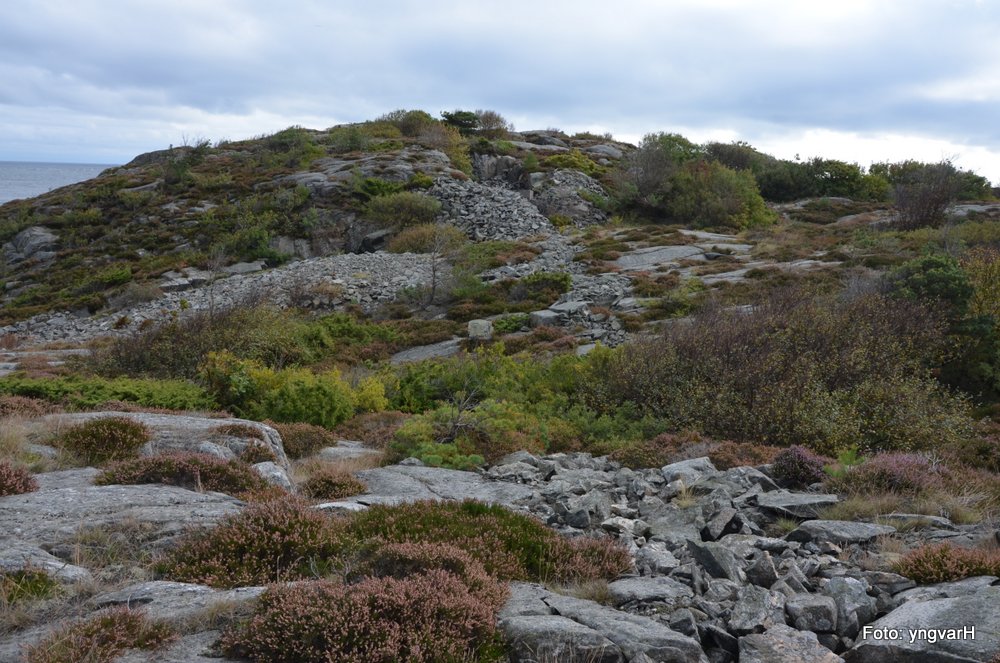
xmin=0 ymin=0 xmax=1000 ymax=184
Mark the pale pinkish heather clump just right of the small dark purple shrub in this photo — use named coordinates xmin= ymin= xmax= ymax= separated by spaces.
xmin=829 ymin=453 xmax=948 ymax=495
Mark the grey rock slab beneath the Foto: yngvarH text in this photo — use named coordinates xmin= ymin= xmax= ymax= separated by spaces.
xmin=844 ymin=587 xmax=1000 ymax=663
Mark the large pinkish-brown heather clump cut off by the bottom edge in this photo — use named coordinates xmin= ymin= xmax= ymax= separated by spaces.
xmin=222 ymin=570 xmax=496 ymax=663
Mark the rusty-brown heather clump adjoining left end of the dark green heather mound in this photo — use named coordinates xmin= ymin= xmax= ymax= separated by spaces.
xmin=160 ymin=497 xmax=337 ymax=587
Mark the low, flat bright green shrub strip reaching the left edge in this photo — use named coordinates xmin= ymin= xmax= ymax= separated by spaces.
xmin=0 ymin=376 xmax=218 ymax=410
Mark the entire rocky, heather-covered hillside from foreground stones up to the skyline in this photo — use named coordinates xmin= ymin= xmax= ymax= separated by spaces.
xmin=0 ymin=111 xmax=1000 ymax=663
